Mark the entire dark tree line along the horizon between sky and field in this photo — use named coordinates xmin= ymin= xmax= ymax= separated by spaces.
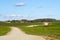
xmin=7 ymin=18 xmax=60 ymax=22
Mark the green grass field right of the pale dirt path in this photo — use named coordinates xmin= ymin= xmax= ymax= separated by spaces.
xmin=16 ymin=22 xmax=60 ymax=36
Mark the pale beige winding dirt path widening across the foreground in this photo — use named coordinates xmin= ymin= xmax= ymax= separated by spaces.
xmin=0 ymin=27 xmax=45 ymax=40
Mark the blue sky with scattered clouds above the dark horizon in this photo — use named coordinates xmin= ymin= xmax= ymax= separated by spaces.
xmin=0 ymin=0 xmax=60 ymax=21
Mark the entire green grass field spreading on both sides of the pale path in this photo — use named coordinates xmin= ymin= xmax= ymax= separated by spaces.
xmin=0 ymin=22 xmax=60 ymax=36
